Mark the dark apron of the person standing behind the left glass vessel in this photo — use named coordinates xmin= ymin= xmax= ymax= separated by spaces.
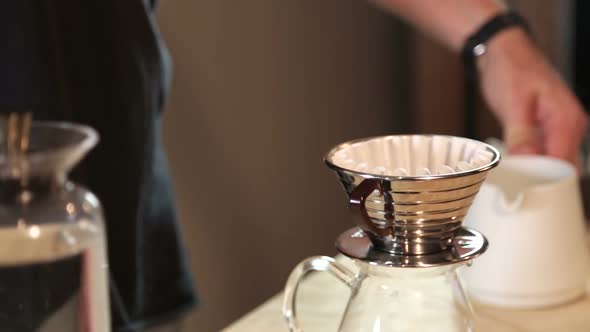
xmin=0 ymin=0 xmax=196 ymax=331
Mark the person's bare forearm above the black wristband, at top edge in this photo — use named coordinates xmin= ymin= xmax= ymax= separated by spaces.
xmin=371 ymin=0 xmax=505 ymax=52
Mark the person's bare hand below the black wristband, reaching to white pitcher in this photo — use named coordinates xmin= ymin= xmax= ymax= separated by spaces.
xmin=477 ymin=28 xmax=587 ymax=165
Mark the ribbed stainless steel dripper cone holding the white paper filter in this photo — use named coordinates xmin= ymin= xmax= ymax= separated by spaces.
xmin=325 ymin=135 xmax=500 ymax=265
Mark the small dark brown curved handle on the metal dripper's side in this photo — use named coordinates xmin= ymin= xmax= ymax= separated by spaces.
xmin=349 ymin=179 xmax=389 ymax=237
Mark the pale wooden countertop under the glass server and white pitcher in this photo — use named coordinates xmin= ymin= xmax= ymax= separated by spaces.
xmin=223 ymin=257 xmax=590 ymax=332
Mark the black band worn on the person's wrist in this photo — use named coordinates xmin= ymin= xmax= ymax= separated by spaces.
xmin=461 ymin=10 xmax=530 ymax=78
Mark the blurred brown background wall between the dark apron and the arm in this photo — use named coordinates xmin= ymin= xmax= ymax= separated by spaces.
xmin=159 ymin=0 xmax=572 ymax=331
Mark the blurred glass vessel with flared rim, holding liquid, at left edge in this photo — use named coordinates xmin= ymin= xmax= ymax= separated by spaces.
xmin=0 ymin=123 xmax=110 ymax=332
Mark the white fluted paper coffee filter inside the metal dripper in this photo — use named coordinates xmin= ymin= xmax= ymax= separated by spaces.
xmin=331 ymin=135 xmax=494 ymax=176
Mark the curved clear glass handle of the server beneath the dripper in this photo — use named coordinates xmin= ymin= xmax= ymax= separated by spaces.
xmin=283 ymin=256 xmax=356 ymax=332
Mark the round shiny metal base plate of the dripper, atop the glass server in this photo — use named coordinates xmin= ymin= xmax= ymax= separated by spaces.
xmin=336 ymin=227 xmax=488 ymax=267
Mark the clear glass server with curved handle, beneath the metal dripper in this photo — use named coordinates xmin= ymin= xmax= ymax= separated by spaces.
xmin=283 ymin=256 xmax=475 ymax=332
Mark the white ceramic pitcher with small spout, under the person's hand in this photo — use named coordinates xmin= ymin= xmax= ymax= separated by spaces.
xmin=462 ymin=156 xmax=590 ymax=308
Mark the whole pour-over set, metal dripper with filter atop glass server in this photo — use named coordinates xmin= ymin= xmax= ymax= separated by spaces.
xmin=283 ymin=135 xmax=500 ymax=332
